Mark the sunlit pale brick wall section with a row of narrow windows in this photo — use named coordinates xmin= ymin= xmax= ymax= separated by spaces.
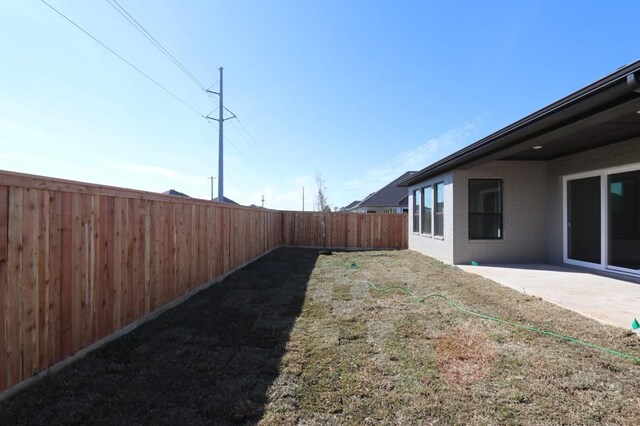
xmin=408 ymin=173 xmax=455 ymax=264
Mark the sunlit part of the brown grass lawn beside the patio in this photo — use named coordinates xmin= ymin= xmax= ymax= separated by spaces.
xmin=262 ymin=251 xmax=640 ymax=425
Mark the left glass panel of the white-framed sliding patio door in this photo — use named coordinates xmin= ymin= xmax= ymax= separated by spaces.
xmin=566 ymin=176 xmax=602 ymax=264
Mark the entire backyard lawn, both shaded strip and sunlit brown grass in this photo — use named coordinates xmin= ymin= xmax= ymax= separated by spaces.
xmin=0 ymin=249 xmax=640 ymax=425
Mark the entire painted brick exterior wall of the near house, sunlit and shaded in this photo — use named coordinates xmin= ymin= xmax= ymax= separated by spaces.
xmin=408 ymin=137 xmax=640 ymax=264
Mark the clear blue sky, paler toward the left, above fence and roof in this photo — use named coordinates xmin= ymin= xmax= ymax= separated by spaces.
xmin=0 ymin=0 xmax=640 ymax=210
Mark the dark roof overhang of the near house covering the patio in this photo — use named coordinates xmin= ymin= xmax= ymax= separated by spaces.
xmin=399 ymin=61 xmax=640 ymax=186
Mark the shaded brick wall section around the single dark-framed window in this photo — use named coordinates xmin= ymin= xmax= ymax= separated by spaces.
xmin=453 ymin=161 xmax=548 ymax=264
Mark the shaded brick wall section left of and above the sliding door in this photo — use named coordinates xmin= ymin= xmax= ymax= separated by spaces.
xmin=547 ymin=138 xmax=640 ymax=264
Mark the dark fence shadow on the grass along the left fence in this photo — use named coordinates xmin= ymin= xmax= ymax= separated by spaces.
xmin=0 ymin=249 xmax=317 ymax=424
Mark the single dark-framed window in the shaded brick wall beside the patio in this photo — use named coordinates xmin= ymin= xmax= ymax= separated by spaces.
xmin=469 ymin=179 xmax=503 ymax=240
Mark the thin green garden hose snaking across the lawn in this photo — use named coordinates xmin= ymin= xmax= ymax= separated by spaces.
xmin=349 ymin=262 xmax=640 ymax=363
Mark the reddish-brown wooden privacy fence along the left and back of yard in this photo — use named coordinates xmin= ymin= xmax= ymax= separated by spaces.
xmin=0 ymin=171 xmax=407 ymax=391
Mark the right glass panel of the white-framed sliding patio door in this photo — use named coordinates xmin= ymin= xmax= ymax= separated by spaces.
xmin=608 ymin=170 xmax=640 ymax=272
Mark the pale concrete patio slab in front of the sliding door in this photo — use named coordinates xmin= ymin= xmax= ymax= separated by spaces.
xmin=457 ymin=264 xmax=640 ymax=330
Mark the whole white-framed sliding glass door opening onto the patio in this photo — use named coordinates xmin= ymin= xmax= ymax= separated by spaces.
xmin=564 ymin=165 xmax=640 ymax=275
